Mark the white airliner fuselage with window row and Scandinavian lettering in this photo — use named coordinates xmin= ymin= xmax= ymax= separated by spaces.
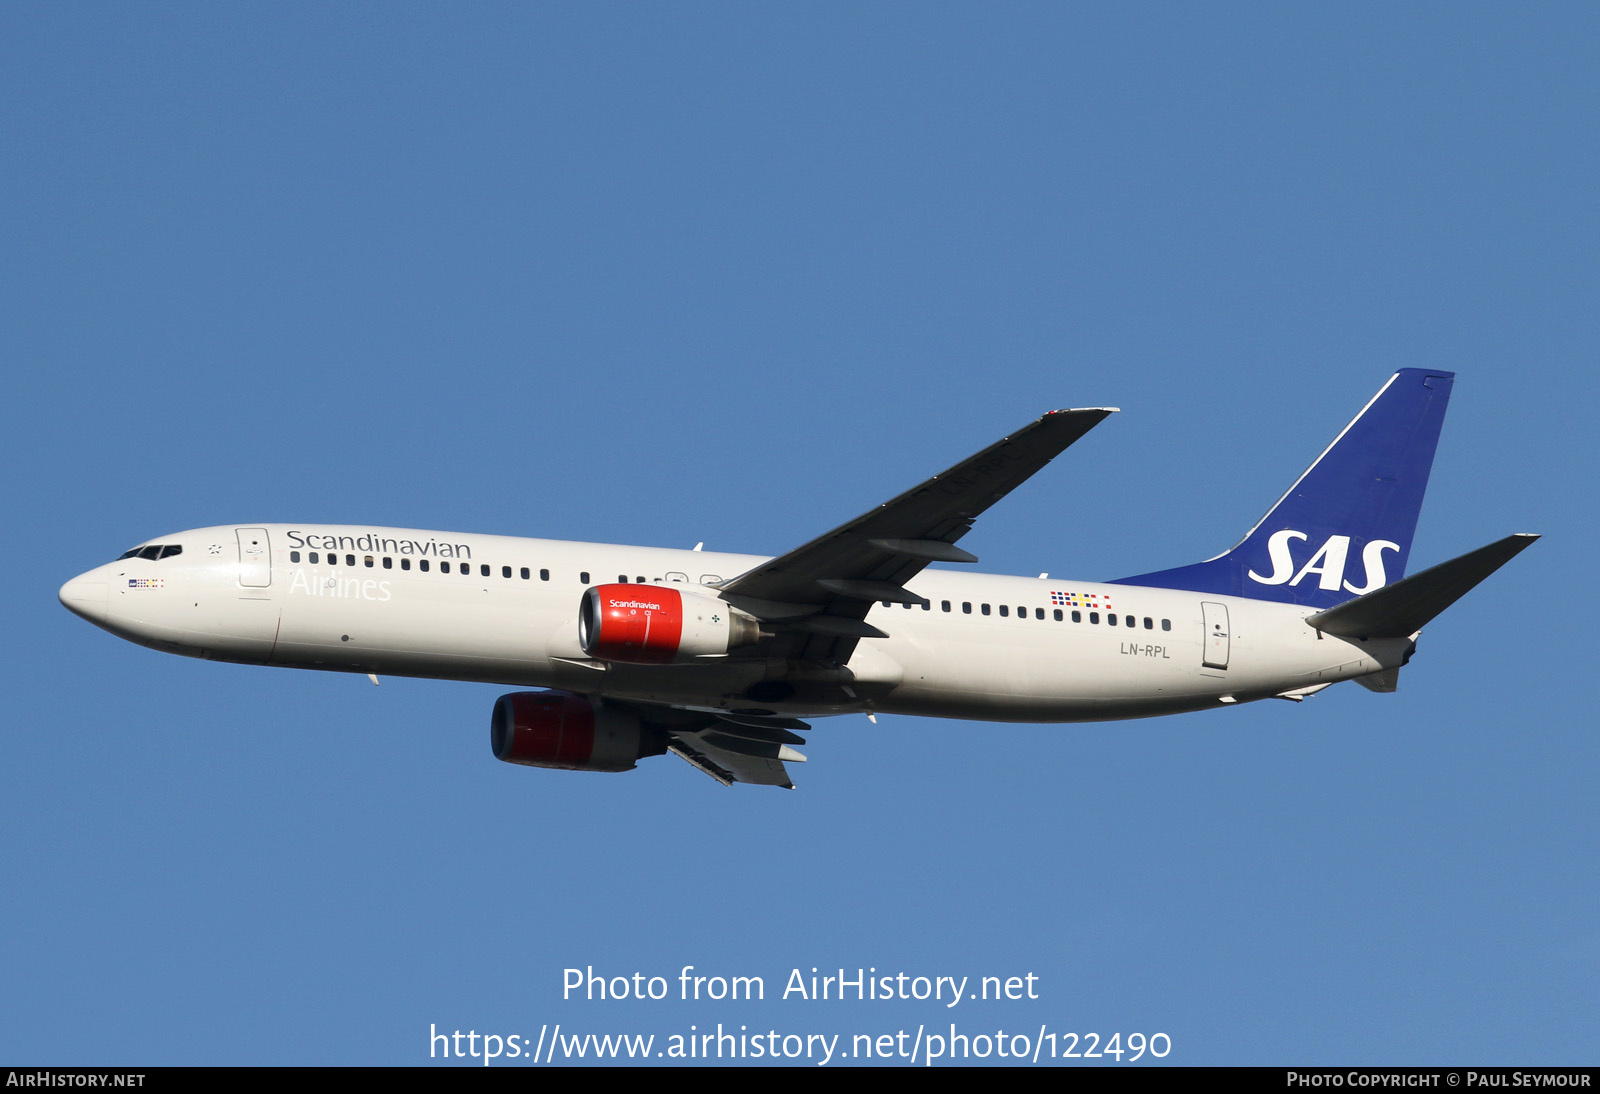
xmin=61 ymin=525 xmax=1411 ymax=721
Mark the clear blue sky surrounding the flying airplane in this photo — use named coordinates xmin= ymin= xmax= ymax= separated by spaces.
xmin=0 ymin=3 xmax=1600 ymax=1064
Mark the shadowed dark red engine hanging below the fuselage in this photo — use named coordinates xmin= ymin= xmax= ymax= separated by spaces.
xmin=490 ymin=691 xmax=666 ymax=771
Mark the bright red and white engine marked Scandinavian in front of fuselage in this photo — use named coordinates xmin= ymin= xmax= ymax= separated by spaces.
xmin=578 ymin=584 xmax=762 ymax=665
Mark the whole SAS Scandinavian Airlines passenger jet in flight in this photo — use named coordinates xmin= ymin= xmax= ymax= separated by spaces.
xmin=59 ymin=368 xmax=1538 ymax=789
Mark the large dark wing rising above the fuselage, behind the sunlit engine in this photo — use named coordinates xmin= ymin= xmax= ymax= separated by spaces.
xmin=720 ymin=406 xmax=1117 ymax=664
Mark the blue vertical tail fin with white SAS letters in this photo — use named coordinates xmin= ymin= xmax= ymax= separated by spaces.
xmin=1112 ymin=368 xmax=1454 ymax=608
